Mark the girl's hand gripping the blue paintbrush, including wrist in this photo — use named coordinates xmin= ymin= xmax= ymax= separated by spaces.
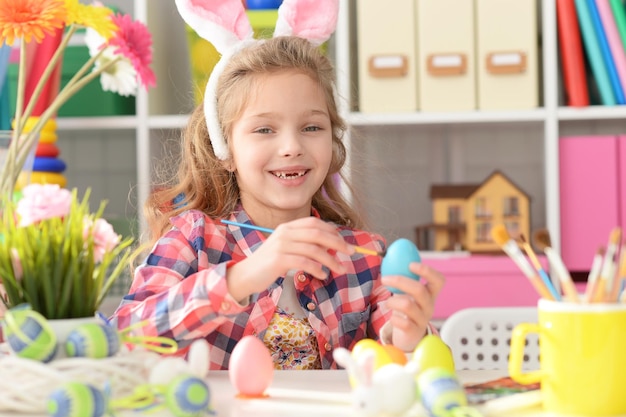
xmin=227 ymin=217 xmax=354 ymax=300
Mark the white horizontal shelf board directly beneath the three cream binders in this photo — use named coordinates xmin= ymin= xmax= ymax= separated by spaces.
xmin=346 ymin=108 xmax=546 ymax=126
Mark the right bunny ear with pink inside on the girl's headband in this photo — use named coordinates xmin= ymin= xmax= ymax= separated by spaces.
xmin=274 ymin=0 xmax=339 ymax=45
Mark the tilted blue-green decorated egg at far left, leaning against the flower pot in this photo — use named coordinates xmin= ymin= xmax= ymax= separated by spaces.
xmin=2 ymin=308 xmax=57 ymax=362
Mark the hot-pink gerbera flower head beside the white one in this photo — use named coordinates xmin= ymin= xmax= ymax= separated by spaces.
xmin=109 ymin=14 xmax=156 ymax=88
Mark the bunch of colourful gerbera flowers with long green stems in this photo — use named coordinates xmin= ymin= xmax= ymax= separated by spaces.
xmin=0 ymin=0 xmax=156 ymax=197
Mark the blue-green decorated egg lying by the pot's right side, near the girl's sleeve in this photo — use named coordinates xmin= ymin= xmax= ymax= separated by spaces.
xmin=65 ymin=323 xmax=120 ymax=358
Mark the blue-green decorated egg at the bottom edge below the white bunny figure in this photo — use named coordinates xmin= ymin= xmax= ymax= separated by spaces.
xmin=165 ymin=374 xmax=211 ymax=417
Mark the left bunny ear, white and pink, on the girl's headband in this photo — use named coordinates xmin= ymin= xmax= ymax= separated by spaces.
xmin=176 ymin=0 xmax=253 ymax=54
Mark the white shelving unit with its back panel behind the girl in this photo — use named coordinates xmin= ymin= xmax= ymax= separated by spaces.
xmin=53 ymin=0 xmax=626 ymax=254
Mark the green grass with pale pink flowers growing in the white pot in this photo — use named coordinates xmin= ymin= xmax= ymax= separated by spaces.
xmin=0 ymin=184 xmax=133 ymax=320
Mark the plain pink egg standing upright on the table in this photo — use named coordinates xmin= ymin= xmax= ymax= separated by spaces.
xmin=228 ymin=336 xmax=274 ymax=397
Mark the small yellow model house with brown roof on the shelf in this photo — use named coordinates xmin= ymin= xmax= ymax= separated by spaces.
xmin=415 ymin=171 xmax=530 ymax=253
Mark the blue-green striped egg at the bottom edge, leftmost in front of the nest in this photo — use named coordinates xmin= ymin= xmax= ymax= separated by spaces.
xmin=47 ymin=382 xmax=106 ymax=417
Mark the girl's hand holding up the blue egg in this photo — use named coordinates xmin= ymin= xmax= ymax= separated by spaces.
xmin=382 ymin=262 xmax=445 ymax=352
